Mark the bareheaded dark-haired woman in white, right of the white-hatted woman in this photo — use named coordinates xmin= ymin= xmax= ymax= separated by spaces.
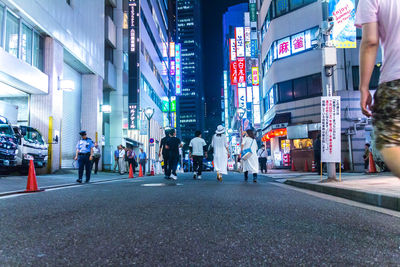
xmin=242 ymin=129 xmax=259 ymax=183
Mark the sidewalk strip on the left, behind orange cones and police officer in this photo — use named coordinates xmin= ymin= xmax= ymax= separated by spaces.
xmin=0 ymin=170 xmax=138 ymax=196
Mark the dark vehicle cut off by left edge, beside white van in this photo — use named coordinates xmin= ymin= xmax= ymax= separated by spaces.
xmin=0 ymin=115 xmax=18 ymax=171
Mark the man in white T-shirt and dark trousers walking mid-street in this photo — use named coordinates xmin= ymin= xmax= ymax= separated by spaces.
xmin=189 ymin=131 xmax=207 ymax=180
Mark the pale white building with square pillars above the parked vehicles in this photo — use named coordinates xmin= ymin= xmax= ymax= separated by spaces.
xmin=0 ymin=0 xmax=104 ymax=172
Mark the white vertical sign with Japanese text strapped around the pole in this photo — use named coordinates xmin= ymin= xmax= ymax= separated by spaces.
xmin=321 ymin=96 xmax=341 ymax=162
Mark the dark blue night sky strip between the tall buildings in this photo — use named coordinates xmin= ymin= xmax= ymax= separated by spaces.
xmin=202 ymin=0 xmax=248 ymax=138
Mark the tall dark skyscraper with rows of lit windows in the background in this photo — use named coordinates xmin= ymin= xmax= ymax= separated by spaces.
xmin=177 ymin=0 xmax=205 ymax=143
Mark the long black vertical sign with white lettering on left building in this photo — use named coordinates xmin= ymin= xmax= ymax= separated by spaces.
xmin=128 ymin=0 xmax=140 ymax=130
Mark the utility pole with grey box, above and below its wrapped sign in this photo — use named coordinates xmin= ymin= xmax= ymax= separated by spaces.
xmin=321 ymin=0 xmax=337 ymax=180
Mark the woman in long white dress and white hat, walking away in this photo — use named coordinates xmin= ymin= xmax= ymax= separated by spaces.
xmin=211 ymin=125 xmax=229 ymax=182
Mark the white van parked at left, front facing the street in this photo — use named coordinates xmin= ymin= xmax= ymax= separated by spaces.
xmin=13 ymin=125 xmax=48 ymax=169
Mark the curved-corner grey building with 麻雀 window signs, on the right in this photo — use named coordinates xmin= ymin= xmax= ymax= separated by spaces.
xmin=257 ymin=0 xmax=380 ymax=171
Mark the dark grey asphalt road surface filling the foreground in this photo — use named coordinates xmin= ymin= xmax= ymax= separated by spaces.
xmin=0 ymin=173 xmax=400 ymax=266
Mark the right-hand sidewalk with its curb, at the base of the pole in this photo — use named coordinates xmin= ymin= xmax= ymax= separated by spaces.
xmin=280 ymin=173 xmax=400 ymax=211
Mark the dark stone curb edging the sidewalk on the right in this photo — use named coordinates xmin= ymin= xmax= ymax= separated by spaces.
xmin=284 ymin=180 xmax=400 ymax=211
